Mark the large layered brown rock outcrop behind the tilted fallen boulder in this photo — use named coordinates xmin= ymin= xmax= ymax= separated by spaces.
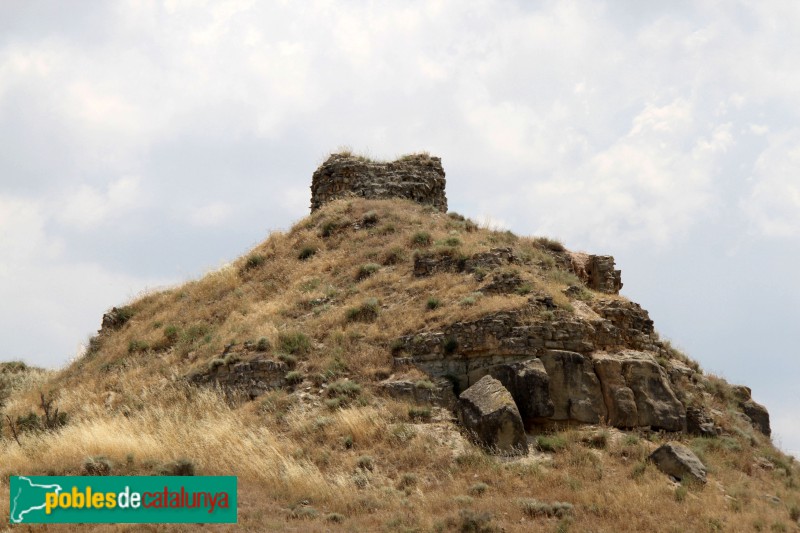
xmin=394 ymin=288 xmax=696 ymax=431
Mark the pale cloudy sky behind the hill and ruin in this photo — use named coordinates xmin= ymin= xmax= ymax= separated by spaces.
xmin=0 ymin=0 xmax=800 ymax=457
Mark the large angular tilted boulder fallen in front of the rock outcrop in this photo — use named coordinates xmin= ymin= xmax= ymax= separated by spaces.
xmin=458 ymin=376 xmax=528 ymax=455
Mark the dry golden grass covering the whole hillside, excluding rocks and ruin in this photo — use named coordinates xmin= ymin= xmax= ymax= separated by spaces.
xmin=0 ymin=199 xmax=800 ymax=532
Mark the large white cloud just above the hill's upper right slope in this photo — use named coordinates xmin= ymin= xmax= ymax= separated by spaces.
xmin=528 ymin=100 xmax=733 ymax=247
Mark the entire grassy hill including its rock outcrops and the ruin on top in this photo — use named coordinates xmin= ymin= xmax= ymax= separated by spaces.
xmin=0 ymin=154 xmax=800 ymax=532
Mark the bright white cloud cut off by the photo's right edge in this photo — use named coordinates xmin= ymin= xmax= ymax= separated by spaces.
xmin=740 ymin=130 xmax=800 ymax=238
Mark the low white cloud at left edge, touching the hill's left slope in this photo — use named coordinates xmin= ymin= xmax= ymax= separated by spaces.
xmin=0 ymin=192 xmax=169 ymax=366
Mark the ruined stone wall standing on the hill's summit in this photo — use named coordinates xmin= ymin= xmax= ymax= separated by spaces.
xmin=311 ymin=154 xmax=447 ymax=212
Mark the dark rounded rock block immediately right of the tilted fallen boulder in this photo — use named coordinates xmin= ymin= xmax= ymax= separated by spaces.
xmin=490 ymin=359 xmax=555 ymax=427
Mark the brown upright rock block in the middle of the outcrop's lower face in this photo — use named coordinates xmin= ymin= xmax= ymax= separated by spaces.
xmin=541 ymin=350 xmax=608 ymax=424
